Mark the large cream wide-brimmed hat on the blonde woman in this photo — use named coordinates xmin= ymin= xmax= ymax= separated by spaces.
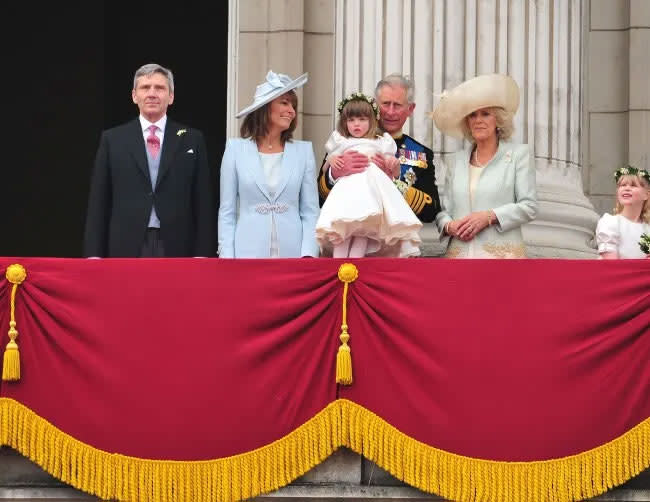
xmin=431 ymin=73 xmax=519 ymax=138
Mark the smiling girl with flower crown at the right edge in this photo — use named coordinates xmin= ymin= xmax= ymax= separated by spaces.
xmin=596 ymin=166 xmax=650 ymax=259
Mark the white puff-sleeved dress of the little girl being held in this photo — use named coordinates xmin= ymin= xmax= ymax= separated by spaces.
xmin=316 ymin=131 xmax=422 ymax=257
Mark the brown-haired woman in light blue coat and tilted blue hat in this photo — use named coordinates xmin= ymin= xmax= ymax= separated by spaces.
xmin=219 ymin=71 xmax=319 ymax=258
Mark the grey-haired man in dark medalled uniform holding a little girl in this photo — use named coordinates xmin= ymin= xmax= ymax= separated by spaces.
xmin=318 ymin=73 xmax=440 ymax=222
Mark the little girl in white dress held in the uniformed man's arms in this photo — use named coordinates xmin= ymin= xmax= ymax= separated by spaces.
xmin=316 ymin=93 xmax=422 ymax=258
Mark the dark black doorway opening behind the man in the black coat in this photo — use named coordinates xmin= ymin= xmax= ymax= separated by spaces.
xmin=0 ymin=0 xmax=228 ymax=257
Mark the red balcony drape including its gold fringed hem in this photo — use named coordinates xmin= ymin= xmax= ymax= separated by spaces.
xmin=0 ymin=258 xmax=650 ymax=501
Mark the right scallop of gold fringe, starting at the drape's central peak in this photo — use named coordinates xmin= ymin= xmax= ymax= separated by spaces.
xmin=342 ymin=401 xmax=650 ymax=502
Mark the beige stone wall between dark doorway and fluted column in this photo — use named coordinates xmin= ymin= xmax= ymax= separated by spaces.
xmin=233 ymin=0 xmax=334 ymax=163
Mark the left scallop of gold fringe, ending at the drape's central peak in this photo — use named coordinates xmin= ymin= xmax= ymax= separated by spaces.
xmin=0 ymin=398 xmax=342 ymax=502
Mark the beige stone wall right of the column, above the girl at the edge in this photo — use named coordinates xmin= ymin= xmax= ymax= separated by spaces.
xmin=583 ymin=0 xmax=650 ymax=214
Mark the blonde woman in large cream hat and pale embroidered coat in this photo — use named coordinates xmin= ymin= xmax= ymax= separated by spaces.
xmin=432 ymin=74 xmax=537 ymax=258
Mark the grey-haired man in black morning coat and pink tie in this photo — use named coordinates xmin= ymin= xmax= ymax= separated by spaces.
xmin=84 ymin=64 xmax=217 ymax=257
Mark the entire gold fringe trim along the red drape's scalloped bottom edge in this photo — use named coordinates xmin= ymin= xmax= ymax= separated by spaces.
xmin=0 ymin=398 xmax=650 ymax=502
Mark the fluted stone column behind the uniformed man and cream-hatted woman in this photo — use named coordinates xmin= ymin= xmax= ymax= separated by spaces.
xmin=334 ymin=0 xmax=598 ymax=258
